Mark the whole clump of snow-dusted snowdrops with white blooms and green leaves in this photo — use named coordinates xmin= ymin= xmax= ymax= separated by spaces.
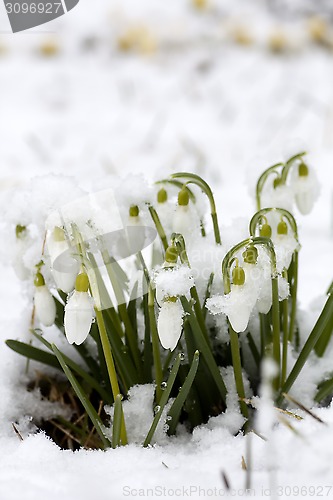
xmin=7 ymin=153 xmax=333 ymax=448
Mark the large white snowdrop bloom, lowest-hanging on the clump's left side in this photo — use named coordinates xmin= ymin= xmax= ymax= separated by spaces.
xmin=64 ymin=273 xmax=94 ymax=345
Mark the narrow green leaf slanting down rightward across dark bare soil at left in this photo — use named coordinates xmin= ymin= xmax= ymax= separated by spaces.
xmin=52 ymin=344 xmax=111 ymax=448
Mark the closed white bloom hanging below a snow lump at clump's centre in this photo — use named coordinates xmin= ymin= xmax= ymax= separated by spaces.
xmin=157 ymin=297 xmax=184 ymax=351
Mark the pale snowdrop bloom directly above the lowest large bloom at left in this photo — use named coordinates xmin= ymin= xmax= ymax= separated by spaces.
xmin=46 ymin=226 xmax=80 ymax=293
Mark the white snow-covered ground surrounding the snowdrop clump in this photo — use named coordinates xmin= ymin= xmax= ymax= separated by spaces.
xmin=0 ymin=0 xmax=333 ymax=500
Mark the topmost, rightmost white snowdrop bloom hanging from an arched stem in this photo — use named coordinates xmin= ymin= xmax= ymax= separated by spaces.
xmin=292 ymin=162 xmax=319 ymax=215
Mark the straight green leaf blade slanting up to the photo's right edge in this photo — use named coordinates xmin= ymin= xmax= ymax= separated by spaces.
xmin=277 ymin=294 xmax=333 ymax=405
